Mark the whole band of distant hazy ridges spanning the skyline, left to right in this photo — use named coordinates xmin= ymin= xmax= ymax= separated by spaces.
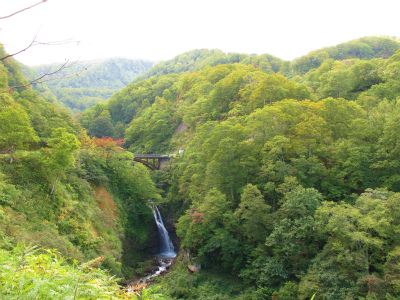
xmin=22 ymin=36 xmax=400 ymax=114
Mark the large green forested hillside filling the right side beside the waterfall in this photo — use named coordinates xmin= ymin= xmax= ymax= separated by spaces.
xmin=79 ymin=37 xmax=400 ymax=299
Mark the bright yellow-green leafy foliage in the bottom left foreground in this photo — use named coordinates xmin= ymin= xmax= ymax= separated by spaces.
xmin=0 ymin=246 xmax=122 ymax=299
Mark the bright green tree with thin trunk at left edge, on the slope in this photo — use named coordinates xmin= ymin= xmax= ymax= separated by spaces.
xmin=0 ymin=104 xmax=39 ymax=164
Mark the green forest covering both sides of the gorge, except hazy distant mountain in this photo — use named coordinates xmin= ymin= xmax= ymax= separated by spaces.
xmin=0 ymin=37 xmax=400 ymax=300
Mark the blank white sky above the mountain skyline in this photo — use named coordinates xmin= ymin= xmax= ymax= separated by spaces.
xmin=0 ymin=0 xmax=400 ymax=65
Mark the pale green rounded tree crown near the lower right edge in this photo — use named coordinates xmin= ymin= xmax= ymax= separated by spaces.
xmin=316 ymin=189 xmax=392 ymax=274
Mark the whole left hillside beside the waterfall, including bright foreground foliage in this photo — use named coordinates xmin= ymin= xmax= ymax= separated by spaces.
xmin=0 ymin=47 xmax=160 ymax=299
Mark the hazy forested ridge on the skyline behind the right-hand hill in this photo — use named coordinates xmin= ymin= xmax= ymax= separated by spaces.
xmin=133 ymin=36 xmax=400 ymax=83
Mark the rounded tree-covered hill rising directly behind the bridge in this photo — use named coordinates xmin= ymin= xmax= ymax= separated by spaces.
xmin=79 ymin=59 xmax=310 ymax=153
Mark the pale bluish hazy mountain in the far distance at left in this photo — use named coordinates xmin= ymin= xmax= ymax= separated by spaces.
xmin=22 ymin=58 xmax=155 ymax=114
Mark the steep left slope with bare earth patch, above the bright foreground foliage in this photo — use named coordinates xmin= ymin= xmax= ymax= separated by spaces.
xmin=0 ymin=47 xmax=159 ymax=284
